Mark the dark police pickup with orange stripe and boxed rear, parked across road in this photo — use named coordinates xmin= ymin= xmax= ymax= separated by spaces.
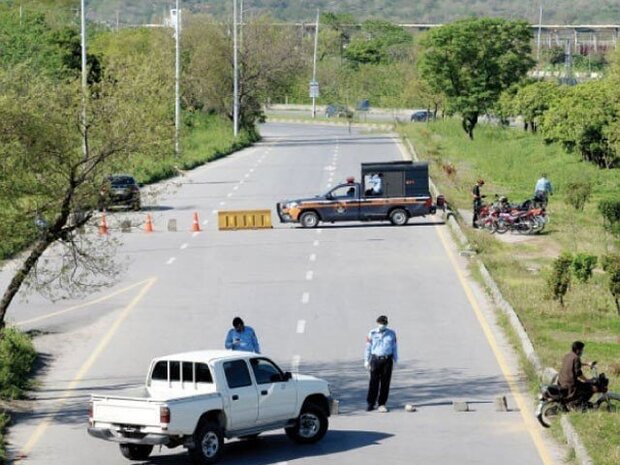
xmin=277 ymin=161 xmax=444 ymax=228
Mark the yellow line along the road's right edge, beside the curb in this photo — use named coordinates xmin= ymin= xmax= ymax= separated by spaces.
xmin=435 ymin=226 xmax=555 ymax=465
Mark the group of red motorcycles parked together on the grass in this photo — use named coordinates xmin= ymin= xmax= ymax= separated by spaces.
xmin=476 ymin=195 xmax=549 ymax=234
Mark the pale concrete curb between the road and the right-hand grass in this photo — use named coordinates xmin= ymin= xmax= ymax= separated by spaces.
xmin=403 ymin=137 xmax=594 ymax=465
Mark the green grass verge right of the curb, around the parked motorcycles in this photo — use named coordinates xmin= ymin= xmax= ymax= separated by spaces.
xmin=399 ymin=120 xmax=620 ymax=465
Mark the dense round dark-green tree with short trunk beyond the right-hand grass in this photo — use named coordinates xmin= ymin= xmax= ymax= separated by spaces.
xmin=419 ymin=18 xmax=534 ymax=139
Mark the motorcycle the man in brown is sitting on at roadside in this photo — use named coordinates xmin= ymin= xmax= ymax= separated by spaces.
xmin=536 ymin=362 xmax=620 ymax=428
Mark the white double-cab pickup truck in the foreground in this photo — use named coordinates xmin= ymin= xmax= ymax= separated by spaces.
xmin=88 ymin=350 xmax=332 ymax=465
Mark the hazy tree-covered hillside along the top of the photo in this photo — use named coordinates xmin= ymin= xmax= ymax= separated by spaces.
xmin=75 ymin=0 xmax=620 ymax=24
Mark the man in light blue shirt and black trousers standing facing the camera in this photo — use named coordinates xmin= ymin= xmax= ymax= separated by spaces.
xmin=364 ymin=315 xmax=398 ymax=413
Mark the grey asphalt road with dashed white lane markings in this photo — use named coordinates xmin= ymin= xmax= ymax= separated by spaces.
xmin=0 ymin=124 xmax=556 ymax=465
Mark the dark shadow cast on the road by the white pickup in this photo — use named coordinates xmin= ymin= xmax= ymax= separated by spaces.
xmin=143 ymin=430 xmax=393 ymax=465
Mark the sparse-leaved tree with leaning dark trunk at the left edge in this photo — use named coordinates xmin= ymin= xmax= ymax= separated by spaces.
xmin=0 ymin=50 xmax=172 ymax=328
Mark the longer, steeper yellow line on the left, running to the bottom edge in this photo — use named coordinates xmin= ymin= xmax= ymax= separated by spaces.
xmin=15 ymin=278 xmax=157 ymax=462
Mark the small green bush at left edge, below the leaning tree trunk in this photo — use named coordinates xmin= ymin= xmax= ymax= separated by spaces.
xmin=0 ymin=328 xmax=37 ymax=399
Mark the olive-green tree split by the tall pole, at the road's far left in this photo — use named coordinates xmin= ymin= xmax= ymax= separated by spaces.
xmin=183 ymin=15 xmax=311 ymax=131
